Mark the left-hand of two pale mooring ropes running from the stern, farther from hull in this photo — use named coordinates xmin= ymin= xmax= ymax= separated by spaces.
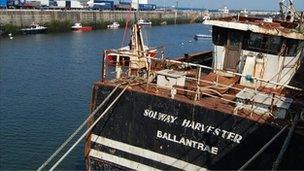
xmin=37 ymin=84 xmax=121 ymax=171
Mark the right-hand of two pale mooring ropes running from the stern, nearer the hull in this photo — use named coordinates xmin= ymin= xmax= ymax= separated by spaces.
xmin=50 ymin=85 xmax=128 ymax=171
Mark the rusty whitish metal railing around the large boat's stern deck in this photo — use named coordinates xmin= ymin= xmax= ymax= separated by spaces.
xmin=101 ymin=51 xmax=303 ymax=111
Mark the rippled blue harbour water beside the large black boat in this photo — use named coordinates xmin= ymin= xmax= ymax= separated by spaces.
xmin=0 ymin=24 xmax=212 ymax=170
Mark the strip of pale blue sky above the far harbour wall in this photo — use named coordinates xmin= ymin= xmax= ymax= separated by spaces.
xmin=149 ymin=0 xmax=304 ymax=11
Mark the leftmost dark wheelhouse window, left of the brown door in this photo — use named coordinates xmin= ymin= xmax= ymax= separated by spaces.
xmin=212 ymin=26 xmax=228 ymax=46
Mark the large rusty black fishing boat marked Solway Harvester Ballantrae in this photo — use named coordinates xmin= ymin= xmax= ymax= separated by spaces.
xmin=85 ymin=0 xmax=304 ymax=170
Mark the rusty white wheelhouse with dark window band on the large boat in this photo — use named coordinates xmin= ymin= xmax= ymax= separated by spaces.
xmin=204 ymin=17 xmax=304 ymax=88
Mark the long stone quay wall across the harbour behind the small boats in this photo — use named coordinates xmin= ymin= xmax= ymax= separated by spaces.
xmin=0 ymin=9 xmax=203 ymax=27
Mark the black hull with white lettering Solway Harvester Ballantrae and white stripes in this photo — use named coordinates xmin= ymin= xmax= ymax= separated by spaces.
xmin=86 ymin=84 xmax=304 ymax=170
